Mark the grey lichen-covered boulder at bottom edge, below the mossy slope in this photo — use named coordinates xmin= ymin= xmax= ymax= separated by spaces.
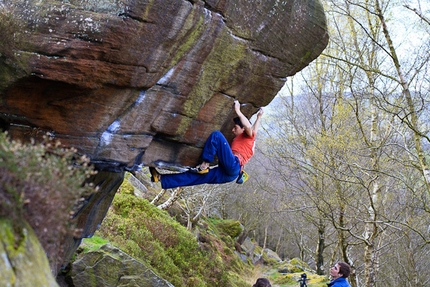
xmin=68 ymin=244 xmax=174 ymax=287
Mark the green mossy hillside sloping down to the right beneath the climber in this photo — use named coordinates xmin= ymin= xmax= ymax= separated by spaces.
xmin=78 ymin=180 xmax=328 ymax=287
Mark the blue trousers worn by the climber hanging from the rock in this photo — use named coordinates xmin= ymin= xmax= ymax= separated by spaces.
xmin=161 ymin=131 xmax=240 ymax=189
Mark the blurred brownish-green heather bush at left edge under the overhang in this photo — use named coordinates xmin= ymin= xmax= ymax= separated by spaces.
xmin=0 ymin=133 xmax=94 ymax=268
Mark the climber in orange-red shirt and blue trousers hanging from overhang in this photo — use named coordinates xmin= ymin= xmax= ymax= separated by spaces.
xmin=149 ymin=100 xmax=263 ymax=189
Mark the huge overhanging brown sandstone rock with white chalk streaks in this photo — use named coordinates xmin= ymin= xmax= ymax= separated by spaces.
xmin=0 ymin=0 xmax=328 ymax=171
